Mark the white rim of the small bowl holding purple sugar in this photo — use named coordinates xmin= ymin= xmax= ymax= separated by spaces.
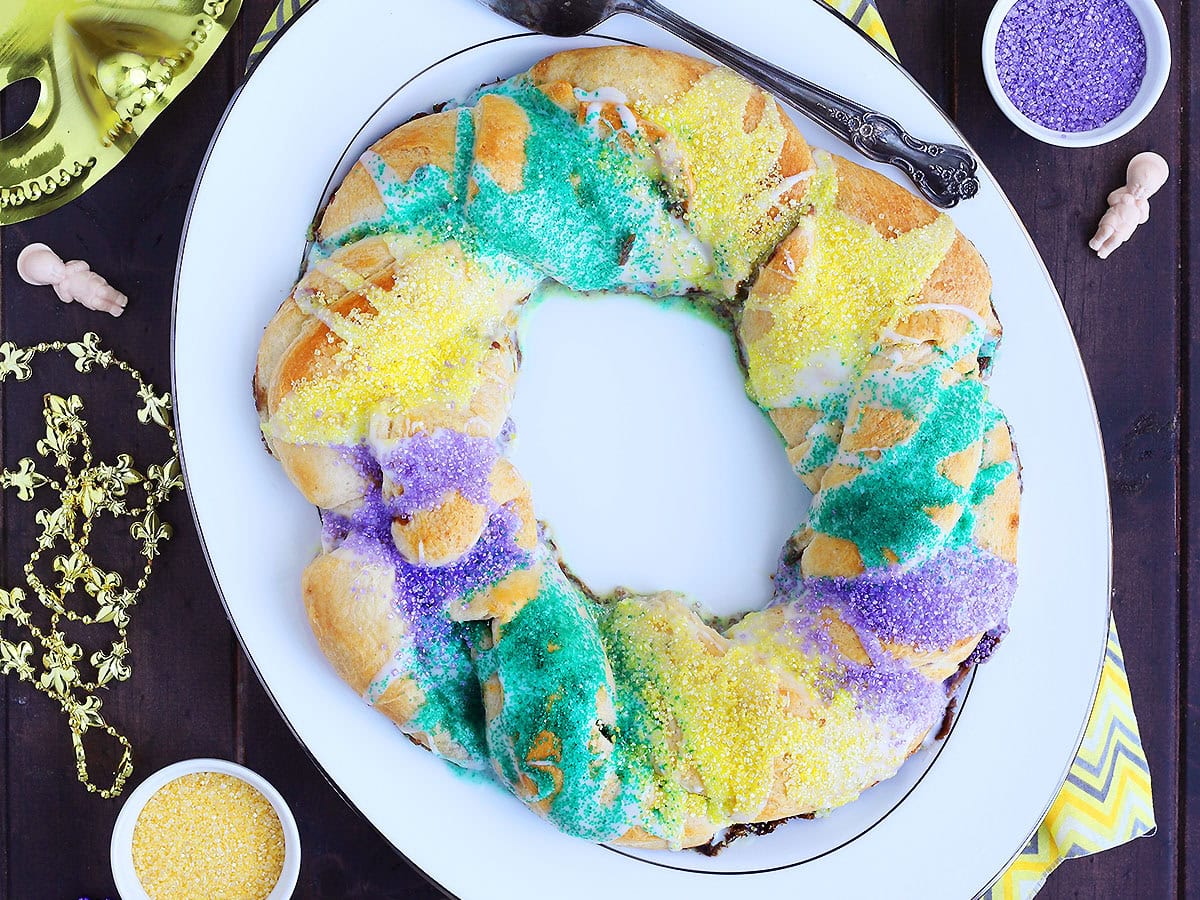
xmin=983 ymin=0 xmax=1171 ymax=146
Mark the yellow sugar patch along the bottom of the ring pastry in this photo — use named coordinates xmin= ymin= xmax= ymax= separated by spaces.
xmin=606 ymin=595 xmax=905 ymax=841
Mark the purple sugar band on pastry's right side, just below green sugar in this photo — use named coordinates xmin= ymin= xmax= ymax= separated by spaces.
xmin=775 ymin=546 xmax=1016 ymax=650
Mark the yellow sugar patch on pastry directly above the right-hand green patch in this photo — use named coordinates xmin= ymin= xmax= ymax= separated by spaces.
xmin=746 ymin=154 xmax=955 ymax=406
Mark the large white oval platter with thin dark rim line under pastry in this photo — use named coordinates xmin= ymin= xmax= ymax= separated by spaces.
xmin=173 ymin=0 xmax=1111 ymax=900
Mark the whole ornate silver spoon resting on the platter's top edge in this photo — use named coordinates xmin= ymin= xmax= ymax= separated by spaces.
xmin=479 ymin=0 xmax=979 ymax=209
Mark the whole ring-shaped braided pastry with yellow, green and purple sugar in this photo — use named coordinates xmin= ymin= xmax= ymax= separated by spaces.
xmin=254 ymin=47 xmax=1020 ymax=848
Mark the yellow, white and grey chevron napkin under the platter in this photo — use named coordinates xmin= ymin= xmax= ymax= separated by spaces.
xmin=246 ymin=0 xmax=1154 ymax=900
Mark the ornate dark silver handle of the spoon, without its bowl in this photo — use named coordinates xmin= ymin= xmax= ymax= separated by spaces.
xmin=616 ymin=0 xmax=979 ymax=209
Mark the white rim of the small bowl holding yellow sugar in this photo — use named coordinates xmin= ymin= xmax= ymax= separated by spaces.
xmin=110 ymin=758 xmax=300 ymax=900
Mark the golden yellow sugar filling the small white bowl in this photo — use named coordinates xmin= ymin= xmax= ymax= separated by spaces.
xmin=133 ymin=772 xmax=283 ymax=900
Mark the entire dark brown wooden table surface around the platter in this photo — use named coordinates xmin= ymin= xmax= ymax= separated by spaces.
xmin=0 ymin=0 xmax=1200 ymax=900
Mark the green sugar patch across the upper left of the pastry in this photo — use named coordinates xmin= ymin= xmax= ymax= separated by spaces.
xmin=314 ymin=78 xmax=679 ymax=290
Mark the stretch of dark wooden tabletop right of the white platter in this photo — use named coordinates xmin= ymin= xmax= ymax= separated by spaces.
xmin=912 ymin=1 xmax=1186 ymax=900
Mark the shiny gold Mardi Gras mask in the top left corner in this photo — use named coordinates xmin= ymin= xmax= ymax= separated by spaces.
xmin=0 ymin=0 xmax=241 ymax=226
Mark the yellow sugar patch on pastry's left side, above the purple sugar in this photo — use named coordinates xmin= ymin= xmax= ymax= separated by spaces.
xmin=270 ymin=247 xmax=516 ymax=444
